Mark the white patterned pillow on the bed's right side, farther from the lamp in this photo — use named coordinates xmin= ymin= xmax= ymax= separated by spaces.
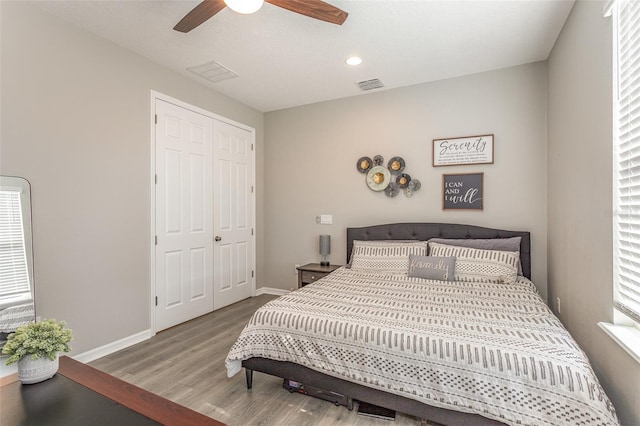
xmin=429 ymin=242 xmax=520 ymax=284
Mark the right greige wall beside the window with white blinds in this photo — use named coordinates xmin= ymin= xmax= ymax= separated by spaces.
xmin=547 ymin=1 xmax=640 ymax=425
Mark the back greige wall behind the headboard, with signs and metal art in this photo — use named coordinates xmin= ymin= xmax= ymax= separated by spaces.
xmin=261 ymin=62 xmax=547 ymax=295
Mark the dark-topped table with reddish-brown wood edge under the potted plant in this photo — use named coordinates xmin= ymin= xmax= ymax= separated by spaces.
xmin=0 ymin=356 xmax=224 ymax=426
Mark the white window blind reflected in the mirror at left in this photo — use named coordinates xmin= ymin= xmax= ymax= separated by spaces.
xmin=0 ymin=188 xmax=31 ymax=304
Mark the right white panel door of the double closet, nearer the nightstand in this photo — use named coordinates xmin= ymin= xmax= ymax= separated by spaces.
xmin=213 ymin=120 xmax=255 ymax=309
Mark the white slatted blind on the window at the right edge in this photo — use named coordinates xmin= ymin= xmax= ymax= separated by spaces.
xmin=613 ymin=0 xmax=640 ymax=321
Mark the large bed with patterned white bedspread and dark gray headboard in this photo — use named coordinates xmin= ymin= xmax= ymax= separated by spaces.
xmin=226 ymin=223 xmax=619 ymax=425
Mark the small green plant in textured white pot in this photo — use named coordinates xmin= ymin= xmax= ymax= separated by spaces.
xmin=2 ymin=319 xmax=72 ymax=384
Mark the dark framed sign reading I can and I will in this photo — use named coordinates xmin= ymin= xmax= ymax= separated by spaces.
xmin=442 ymin=173 xmax=484 ymax=210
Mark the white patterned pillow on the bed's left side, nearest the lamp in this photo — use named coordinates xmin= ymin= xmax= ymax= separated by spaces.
xmin=351 ymin=240 xmax=427 ymax=274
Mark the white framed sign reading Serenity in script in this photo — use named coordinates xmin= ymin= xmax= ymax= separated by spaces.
xmin=433 ymin=135 xmax=493 ymax=167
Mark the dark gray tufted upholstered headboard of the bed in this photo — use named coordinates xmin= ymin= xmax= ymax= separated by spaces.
xmin=347 ymin=223 xmax=531 ymax=279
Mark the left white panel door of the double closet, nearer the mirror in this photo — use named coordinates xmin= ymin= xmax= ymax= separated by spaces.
xmin=155 ymin=99 xmax=213 ymax=331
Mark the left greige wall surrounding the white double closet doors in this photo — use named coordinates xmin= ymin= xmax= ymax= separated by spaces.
xmin=0 ymin=2 xmax=264 ymax=354
